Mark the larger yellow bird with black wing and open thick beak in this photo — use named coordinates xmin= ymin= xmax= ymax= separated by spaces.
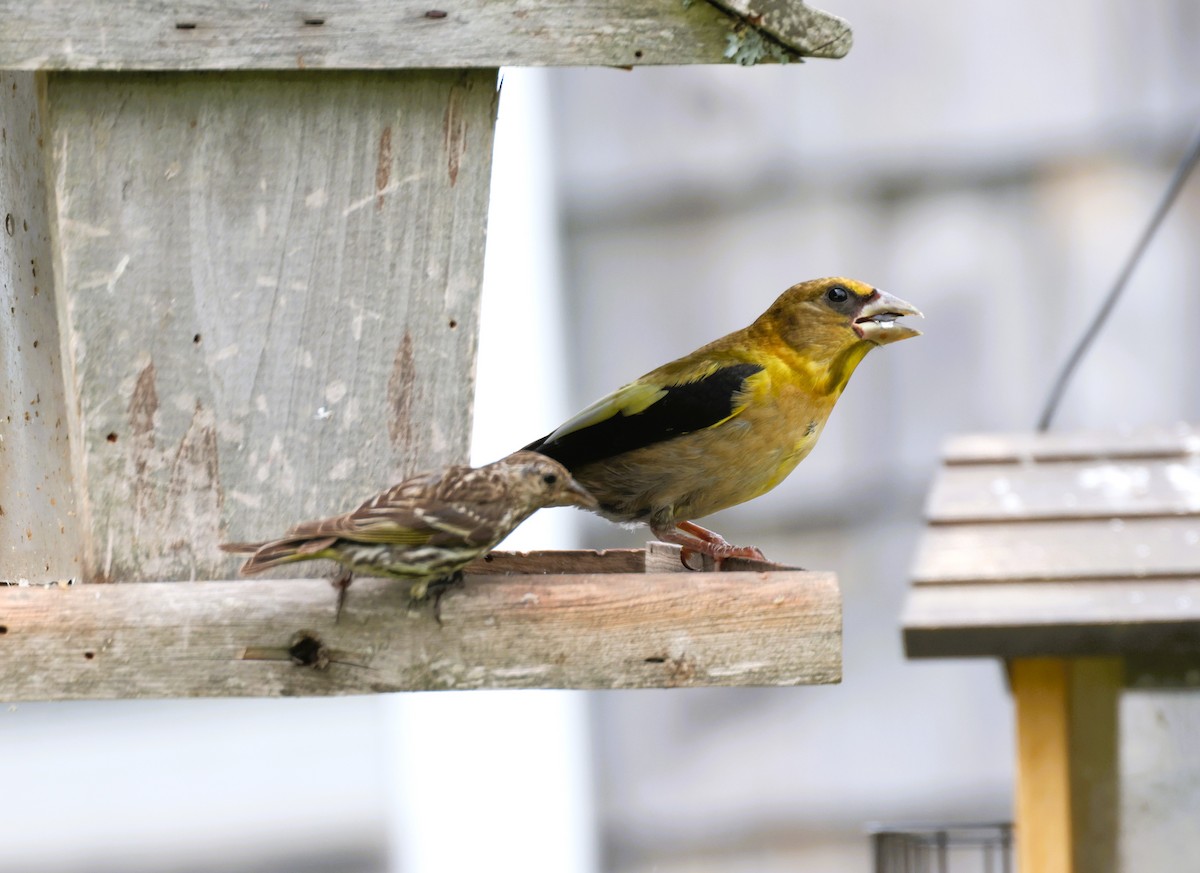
xmin=526 ymin=278 xmax=920 ymax=562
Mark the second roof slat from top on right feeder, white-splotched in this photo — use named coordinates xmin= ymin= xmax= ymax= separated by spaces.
xmin=925 ymin=454 xmax=1200 ymax=523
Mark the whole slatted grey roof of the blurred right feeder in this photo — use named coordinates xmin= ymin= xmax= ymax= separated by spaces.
xmin=902 ymin=426 xmax=1200 ymax=657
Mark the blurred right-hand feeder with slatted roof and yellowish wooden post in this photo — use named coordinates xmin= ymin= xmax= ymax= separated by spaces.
xmin=902 ymin=426 xmax=1200 ymax=873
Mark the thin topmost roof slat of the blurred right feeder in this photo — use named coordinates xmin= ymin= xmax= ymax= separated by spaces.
xmin=942 ymin=422 xmax=1200 ymax=464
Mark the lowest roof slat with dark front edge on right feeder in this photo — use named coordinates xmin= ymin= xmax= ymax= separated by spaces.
xmin=901 ymin=578 xmax=1200 ymax=657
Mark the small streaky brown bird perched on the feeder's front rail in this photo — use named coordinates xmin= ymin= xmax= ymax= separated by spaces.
xmin=221 ymin=452 xmax=596 ymax=615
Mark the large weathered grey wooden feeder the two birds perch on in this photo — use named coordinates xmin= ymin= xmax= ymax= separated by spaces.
xmin=0 ymin=0 xmax=851 ymax=700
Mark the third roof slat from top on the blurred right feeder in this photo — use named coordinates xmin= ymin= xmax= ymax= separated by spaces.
xmin=912 ymin=517 xmax=1200 ymax=585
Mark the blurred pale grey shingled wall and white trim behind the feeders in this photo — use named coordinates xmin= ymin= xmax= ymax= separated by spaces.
xmin=0 ymin=0 xmax=1200 ymax=873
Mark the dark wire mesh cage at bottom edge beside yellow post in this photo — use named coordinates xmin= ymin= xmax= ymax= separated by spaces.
xmin=871 ymin=823 xmax=1013 ymax=873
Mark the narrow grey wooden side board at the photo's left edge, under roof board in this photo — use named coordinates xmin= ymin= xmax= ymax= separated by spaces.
xmin=0 ymin=72 xmax=82 ymax=582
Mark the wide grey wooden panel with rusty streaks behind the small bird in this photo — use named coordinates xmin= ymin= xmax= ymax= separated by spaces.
xmin=46 ymin=71 xmax=496 ymax=582
